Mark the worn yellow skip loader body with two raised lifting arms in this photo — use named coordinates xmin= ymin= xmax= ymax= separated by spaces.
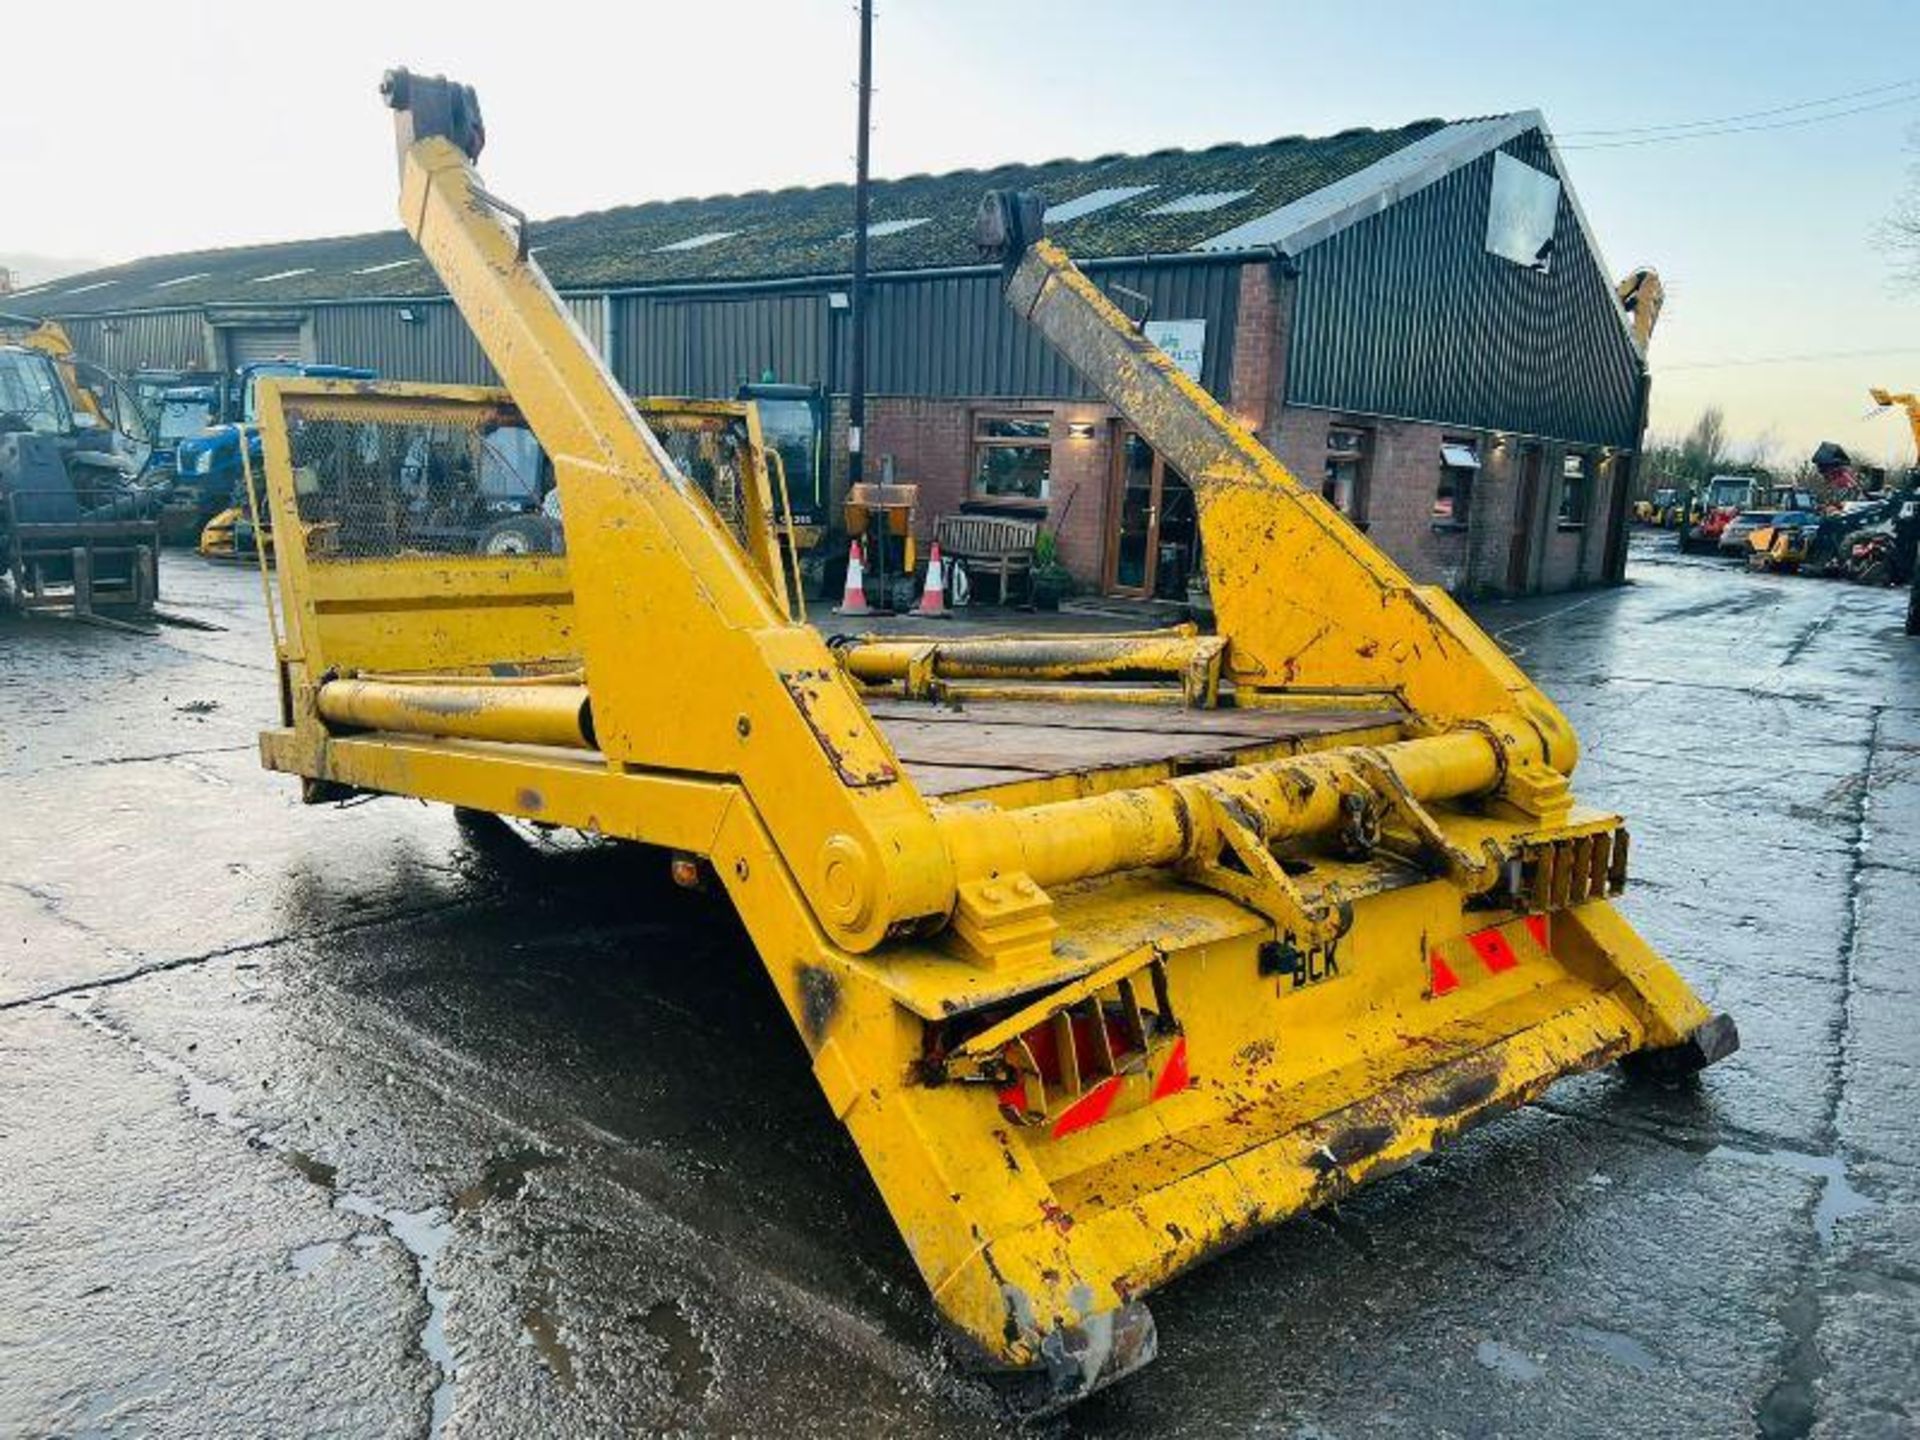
xmin=247 ymin=71 xmax=1738 ymax=1404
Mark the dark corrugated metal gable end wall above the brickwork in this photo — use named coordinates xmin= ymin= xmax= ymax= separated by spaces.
xmin=1286 ymin=131 xmax=1640 ymax=447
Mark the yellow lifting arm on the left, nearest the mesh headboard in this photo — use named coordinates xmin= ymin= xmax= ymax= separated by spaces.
xmin=382 ymin=69 xmax=952 ymax=950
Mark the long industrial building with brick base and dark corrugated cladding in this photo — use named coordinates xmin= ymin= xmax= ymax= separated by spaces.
xmin=6 ymin=111 xmax=1647 ymax=597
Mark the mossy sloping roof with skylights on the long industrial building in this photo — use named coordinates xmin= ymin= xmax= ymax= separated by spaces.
xmin=6 ymin=111 xmax=1542 ymax=315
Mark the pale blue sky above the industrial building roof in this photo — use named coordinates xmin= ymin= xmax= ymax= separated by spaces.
xmin=0 ymin=0 xmax=1920 ymax=461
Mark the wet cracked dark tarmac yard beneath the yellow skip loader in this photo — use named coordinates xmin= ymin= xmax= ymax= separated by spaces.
xmin=0 ymin=536 xmax=1920 ymax=1436
